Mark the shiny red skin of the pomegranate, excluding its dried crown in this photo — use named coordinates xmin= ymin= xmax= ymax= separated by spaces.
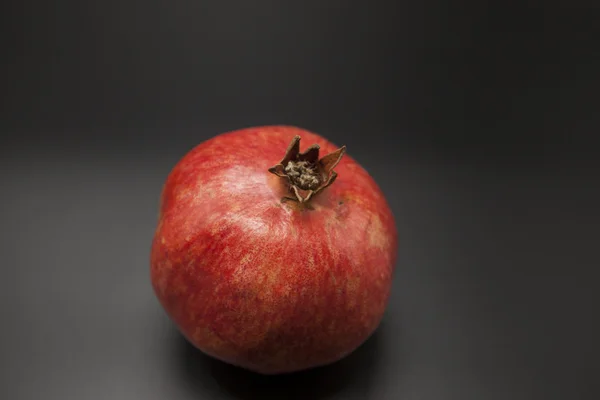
xmin=150 ymin=126 xmax=397 ymax=374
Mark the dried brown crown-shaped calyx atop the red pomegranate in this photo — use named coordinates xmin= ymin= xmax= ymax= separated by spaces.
xmin=269 ymin=136 xmax=346 ymax=203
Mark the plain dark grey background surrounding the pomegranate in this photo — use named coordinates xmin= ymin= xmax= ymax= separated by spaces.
xmin=0 ymin=0 xmax=600 ymax=400
